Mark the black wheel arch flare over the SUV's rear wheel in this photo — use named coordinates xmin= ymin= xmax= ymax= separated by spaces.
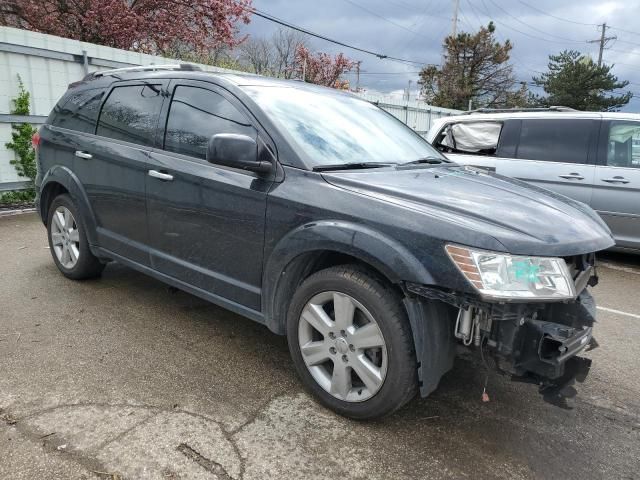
xmin=38 ymin=165 xmax=97 ymax=245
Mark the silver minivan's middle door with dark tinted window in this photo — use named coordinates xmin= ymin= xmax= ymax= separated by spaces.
xmin=496 ymin=118 xmax=599 ymax=204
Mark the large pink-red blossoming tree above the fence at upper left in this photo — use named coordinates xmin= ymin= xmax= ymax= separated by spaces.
xmin=0 ymin=0 xmax=251 ymax=54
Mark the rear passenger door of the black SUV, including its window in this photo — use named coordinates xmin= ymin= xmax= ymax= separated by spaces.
xmin=81 ymin=80 xmax=166 ymax=265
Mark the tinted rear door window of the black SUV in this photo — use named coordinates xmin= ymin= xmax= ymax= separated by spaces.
xmin=96 ymin=85 xmax=162 ymax=145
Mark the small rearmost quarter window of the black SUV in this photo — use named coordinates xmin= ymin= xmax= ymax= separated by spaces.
xmin=51 ymin=89 xmax=105 ymax=133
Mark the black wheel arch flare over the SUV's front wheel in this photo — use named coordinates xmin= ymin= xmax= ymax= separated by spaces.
xmin=262 ymin=220 xmax=434 ymax=333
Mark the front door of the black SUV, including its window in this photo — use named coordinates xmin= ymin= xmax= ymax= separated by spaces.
xmin=146 ymin=81 xmax=271 ymax=311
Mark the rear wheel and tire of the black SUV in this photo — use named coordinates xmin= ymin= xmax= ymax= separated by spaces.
xmin=47 ymin=194 xmax=105 ymax=280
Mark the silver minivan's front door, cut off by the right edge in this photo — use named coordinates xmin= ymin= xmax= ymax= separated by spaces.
xmin=591 ymin=120 xmax=640 ymax=249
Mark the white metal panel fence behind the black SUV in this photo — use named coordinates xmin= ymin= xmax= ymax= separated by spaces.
xmin=0 ymin=27 xmax=458 ymax=192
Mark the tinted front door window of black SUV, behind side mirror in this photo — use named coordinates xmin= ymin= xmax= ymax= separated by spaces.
xmin=164 ymin=86 xmax=256 ymax=159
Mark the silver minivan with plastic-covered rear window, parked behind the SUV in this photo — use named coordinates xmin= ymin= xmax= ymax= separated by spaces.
xmin=427 ymin=107 xmax=640 ymax=253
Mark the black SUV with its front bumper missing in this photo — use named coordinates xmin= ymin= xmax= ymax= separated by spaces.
xmin=34 ymin=66 xmax=614 ymax=418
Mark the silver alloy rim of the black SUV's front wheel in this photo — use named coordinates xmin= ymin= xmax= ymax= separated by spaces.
xmin=298 ymin=291 xmax=387 ymax=402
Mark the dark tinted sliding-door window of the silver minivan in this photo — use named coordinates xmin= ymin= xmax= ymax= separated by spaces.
xmin=516 ymin=119 xmax=593 ymax=163
